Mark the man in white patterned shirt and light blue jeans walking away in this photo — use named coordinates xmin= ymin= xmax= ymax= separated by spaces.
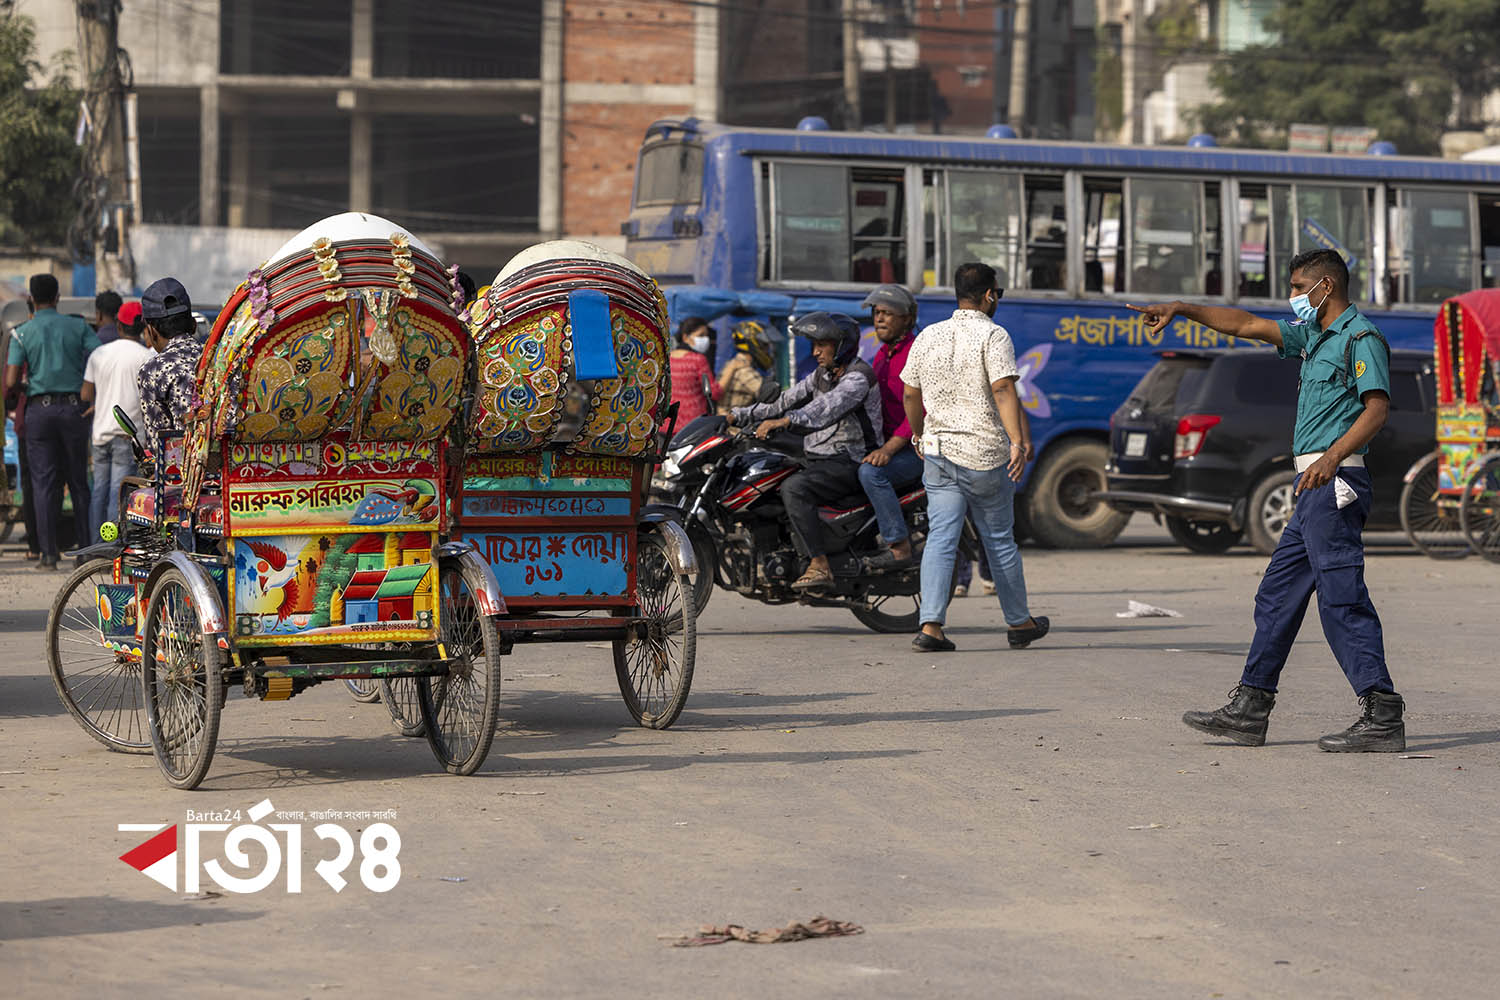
xmin=902 ymin=264 xmax=1052 ymax=652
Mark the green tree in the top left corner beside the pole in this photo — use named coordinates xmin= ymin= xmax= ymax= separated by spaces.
xmin=0 ymin=0 xmax=80 ymax=249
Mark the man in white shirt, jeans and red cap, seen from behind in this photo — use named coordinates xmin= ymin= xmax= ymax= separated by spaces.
xmin=78 ymin=303 xmax=152 ymax=544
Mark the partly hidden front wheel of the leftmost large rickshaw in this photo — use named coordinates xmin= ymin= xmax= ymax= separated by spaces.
xmin=47 ymin=559 xmax=152 ymax=754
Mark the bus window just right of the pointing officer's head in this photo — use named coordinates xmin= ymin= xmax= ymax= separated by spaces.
xmin=1388 ymin=190 xmax=1475 ymax=303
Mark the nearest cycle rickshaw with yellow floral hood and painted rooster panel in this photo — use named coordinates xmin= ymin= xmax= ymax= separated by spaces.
xmin=48 ymin=213 xmax=506 ymax=789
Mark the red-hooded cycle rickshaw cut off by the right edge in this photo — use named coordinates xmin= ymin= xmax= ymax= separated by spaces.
xmin=1401 ymin=289 xmax=1500 ymax=561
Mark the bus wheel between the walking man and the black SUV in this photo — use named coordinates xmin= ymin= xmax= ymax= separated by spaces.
xmin=1026 ymin=439 xmax=1130 ymax=549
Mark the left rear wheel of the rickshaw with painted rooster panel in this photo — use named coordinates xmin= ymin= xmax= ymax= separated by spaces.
xmin=141 ymin=568 xmax=225 ymax=789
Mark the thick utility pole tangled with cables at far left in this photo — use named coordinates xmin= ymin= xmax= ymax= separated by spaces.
xmin=75 ymin=0 xmax=135 ymax=292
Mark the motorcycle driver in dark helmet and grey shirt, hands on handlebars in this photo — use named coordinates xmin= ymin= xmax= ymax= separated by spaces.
xmin=729 ymin=312 xmax=881 ymax=591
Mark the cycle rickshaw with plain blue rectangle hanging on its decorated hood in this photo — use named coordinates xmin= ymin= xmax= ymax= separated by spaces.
xmin=453 ymin=240 xmax=698 ymax=729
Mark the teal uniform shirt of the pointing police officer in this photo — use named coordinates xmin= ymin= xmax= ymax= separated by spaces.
xmin=1277 ymin=306 xmax=1391 ymax=454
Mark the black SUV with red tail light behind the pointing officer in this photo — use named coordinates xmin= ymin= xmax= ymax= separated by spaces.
xmin=1098 ymin=349 xmax=1437 ymax=555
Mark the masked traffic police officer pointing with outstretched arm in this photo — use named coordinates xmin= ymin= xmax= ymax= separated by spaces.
xmin=1131 ymin=250 xmax=1406 ymax=753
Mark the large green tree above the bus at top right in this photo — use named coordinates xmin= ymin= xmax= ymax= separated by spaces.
xmin=1199 ymin=0 xmax=1500 ymax=154
